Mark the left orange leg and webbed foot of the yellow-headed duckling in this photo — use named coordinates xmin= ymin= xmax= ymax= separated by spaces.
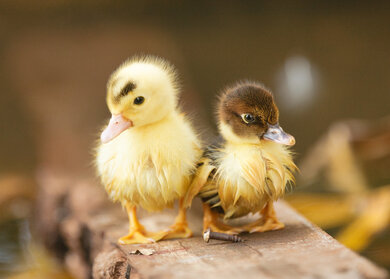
xmin=118 ymin=203 xmax=166 ymax=244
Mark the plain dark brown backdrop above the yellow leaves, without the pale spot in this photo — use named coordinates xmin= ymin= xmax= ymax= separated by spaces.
xmin=0 ymin=0 xmax=390 ymax=175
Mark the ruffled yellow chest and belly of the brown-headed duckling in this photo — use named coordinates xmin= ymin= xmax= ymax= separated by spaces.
xmin=213 ymin=145 xmax=287 ymax=217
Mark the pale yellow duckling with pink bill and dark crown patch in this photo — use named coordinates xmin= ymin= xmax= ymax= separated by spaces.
xmin=96 ymin=56 xmax=202 ymax=244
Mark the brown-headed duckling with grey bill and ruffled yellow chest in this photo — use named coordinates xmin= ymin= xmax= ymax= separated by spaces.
xmin=185 ymin=81 xmax=297 ymax=234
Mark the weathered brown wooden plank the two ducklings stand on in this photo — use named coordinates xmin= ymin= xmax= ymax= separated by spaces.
xmin=37 ymin=176 xmax=387 ymax=279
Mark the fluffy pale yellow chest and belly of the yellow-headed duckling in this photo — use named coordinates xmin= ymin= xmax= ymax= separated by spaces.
xmin=97 ymin=123 xmax=199 ymax=211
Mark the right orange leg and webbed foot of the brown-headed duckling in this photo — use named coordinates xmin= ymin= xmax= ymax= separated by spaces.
xmin=243 ymin=201 xmax=284 ymax=233
